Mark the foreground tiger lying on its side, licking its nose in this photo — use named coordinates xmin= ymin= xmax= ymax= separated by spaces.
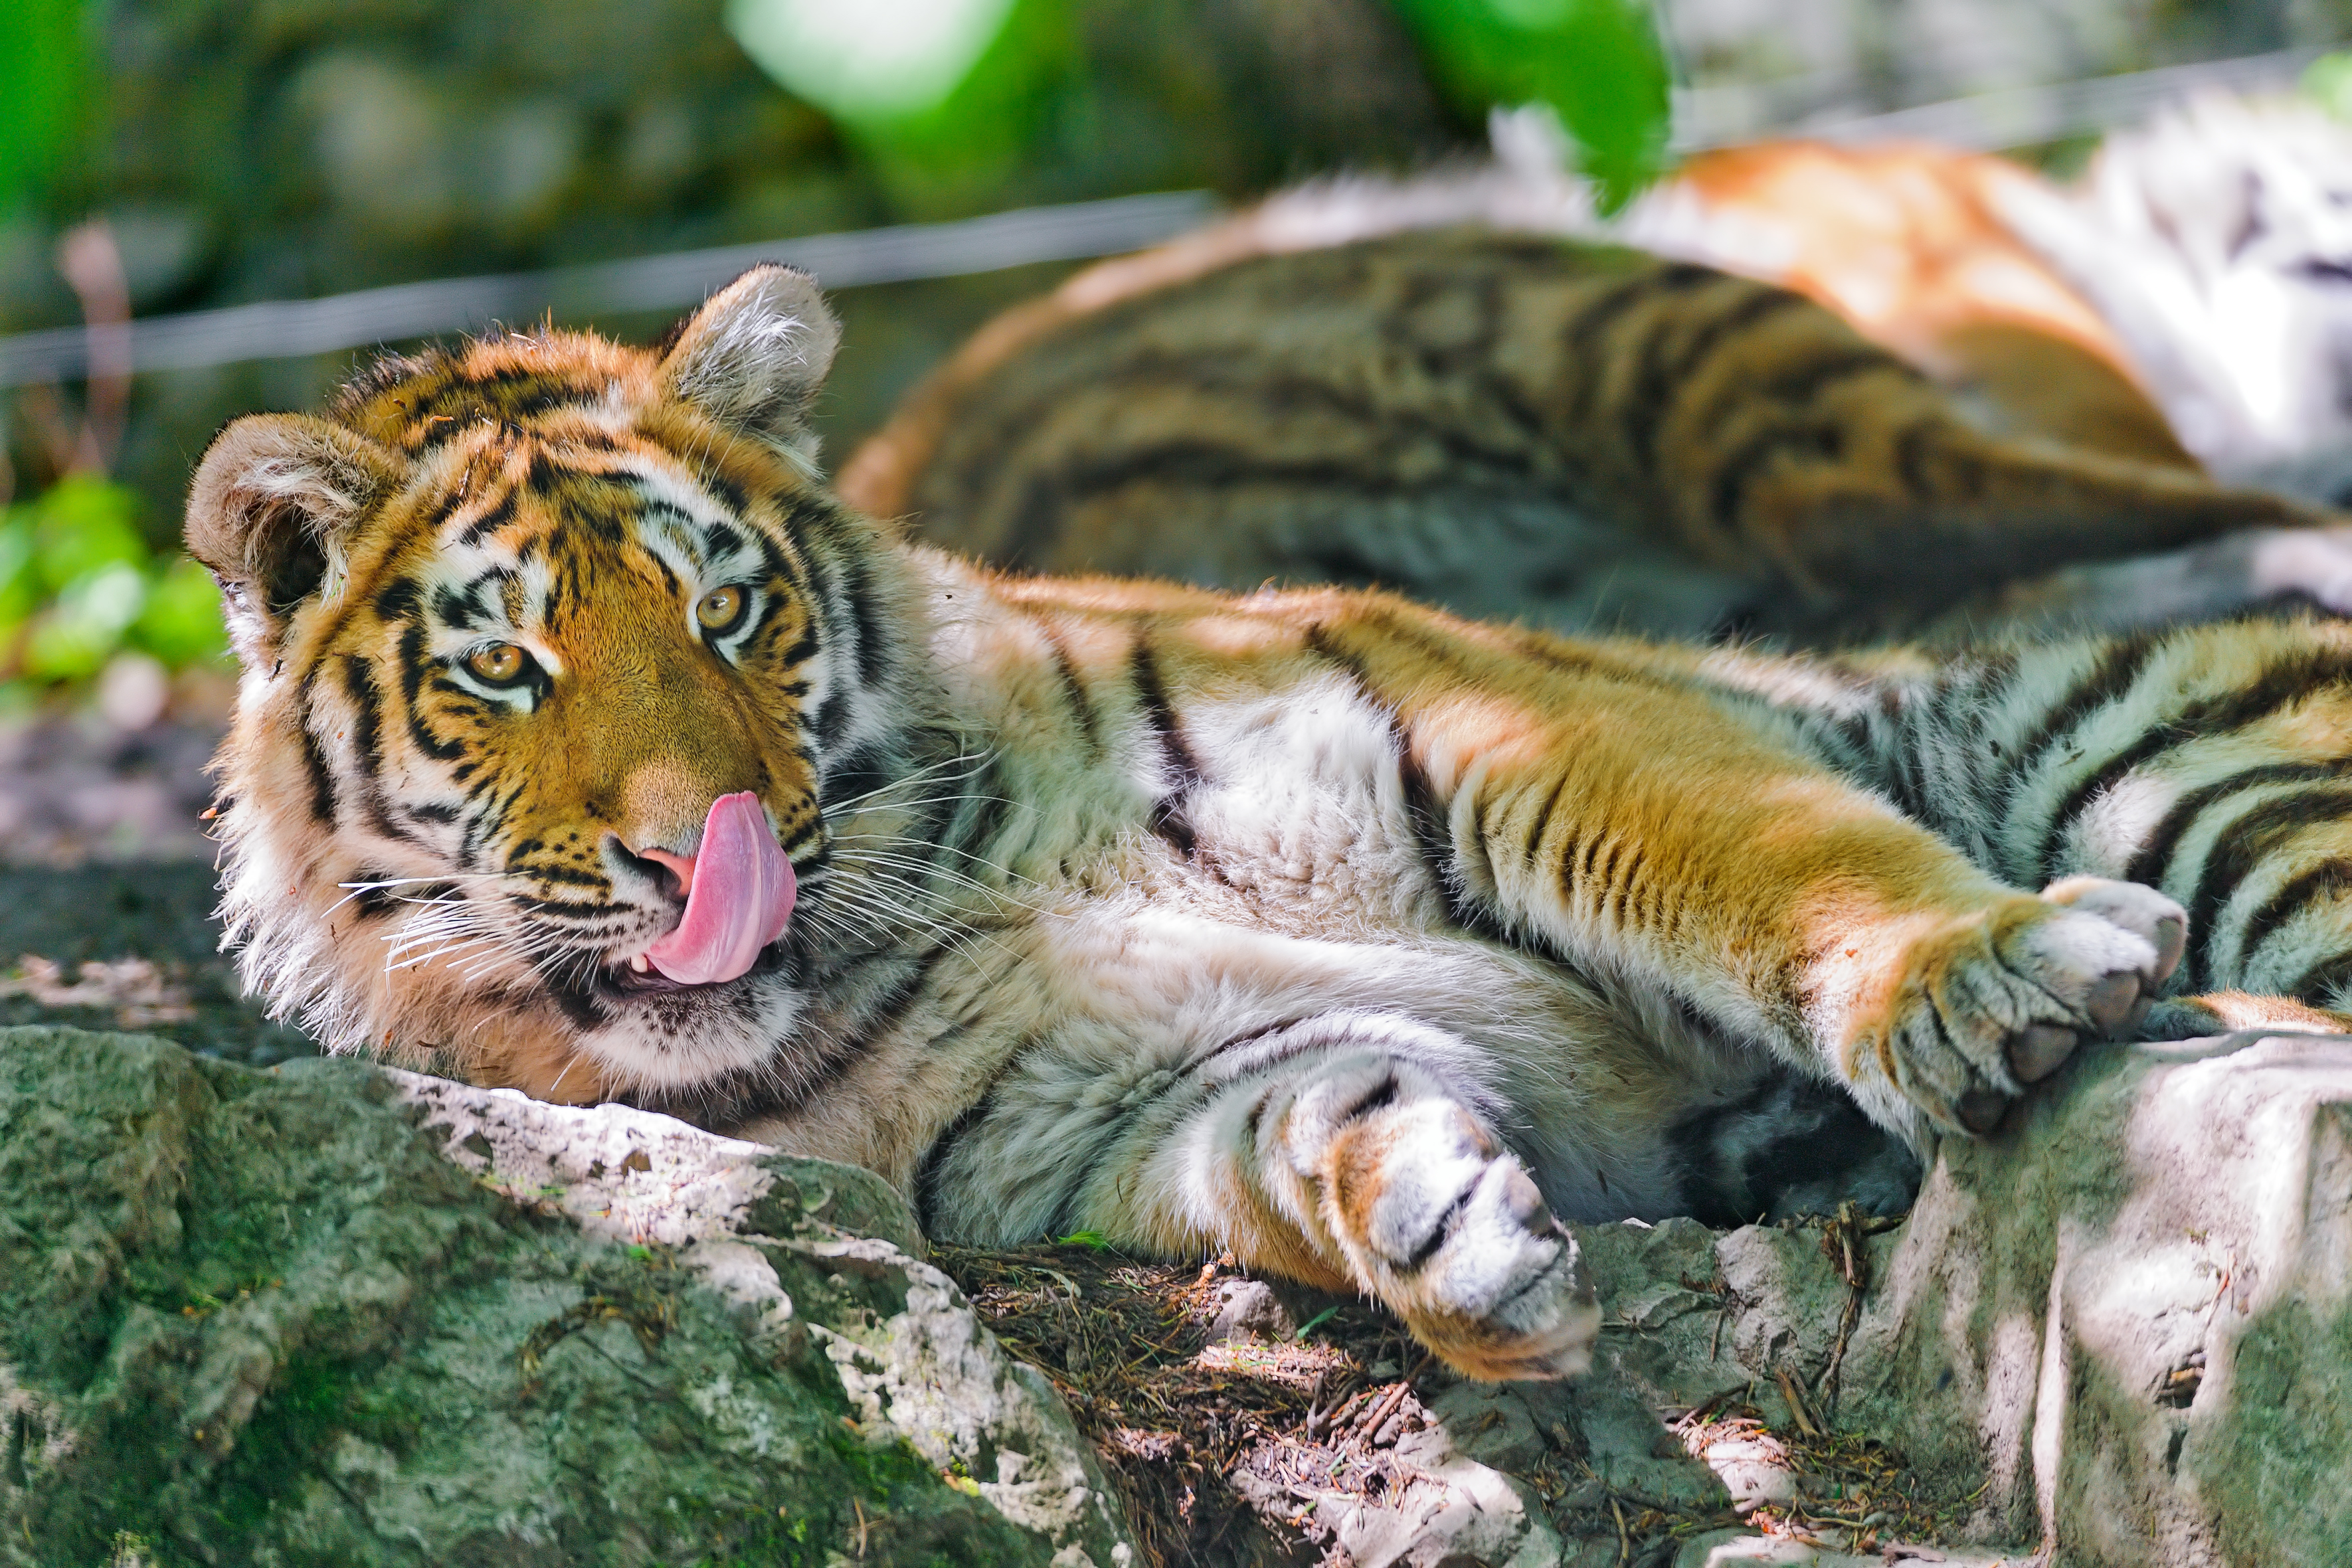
xmin=188 ymin=268 xmax=2352 ymax=1377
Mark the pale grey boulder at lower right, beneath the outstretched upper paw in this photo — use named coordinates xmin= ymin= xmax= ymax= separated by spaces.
xmin=1844 ymin=1037 xmax=2352 ymax=1568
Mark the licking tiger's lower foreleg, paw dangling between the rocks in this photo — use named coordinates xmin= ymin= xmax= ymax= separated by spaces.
xmin=917 ymin=1013 xmax=1599 ymax=1380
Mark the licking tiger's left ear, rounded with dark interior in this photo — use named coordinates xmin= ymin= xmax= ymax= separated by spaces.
xmin=188 ymin=414 xmax=403 ymax=665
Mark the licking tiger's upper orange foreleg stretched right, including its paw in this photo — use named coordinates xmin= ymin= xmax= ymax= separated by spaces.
xmin=1322 ymin=604 xmax=2187 ymax=1133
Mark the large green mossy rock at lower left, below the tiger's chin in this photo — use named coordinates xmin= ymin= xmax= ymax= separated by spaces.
xmin=0 ymin=1027 xmax=1131 ymax=1568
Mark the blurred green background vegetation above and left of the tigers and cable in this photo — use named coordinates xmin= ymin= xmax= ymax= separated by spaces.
xmin=0 ymin=0 xmax=2352 ymax=705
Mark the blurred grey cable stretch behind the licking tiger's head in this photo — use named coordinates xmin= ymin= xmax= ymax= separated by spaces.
xmin=0 ymin=191 xmax=1216 ymax=386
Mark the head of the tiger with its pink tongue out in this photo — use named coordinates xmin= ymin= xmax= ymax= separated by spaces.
xmin=188 ymin=268 xmax=917 ymax=1102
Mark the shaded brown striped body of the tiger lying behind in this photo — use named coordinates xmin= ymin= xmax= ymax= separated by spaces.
xmin=842 ymin=228 xmax=2321 ymax=642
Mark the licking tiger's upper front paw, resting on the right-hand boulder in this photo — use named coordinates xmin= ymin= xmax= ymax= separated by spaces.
xmin=1856 ymin=877 xmax=2187 ymax=1136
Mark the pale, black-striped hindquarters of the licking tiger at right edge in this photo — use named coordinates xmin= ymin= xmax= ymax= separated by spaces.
xmin=1743 ymin=620 xmax=2352 ymax=1039
